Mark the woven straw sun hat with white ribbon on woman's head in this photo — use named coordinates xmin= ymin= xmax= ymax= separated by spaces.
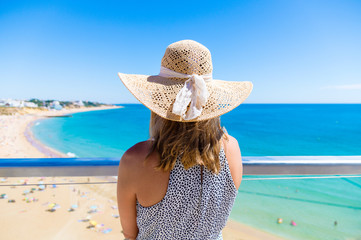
xmin=118 ymin=40 xmax=253 ymax=122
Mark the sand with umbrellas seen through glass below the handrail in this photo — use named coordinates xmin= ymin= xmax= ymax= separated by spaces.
xmin=0 ymin=177 xmax=282 ymax=240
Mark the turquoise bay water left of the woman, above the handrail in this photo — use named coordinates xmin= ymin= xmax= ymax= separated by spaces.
xmin=32 ymin=104 xmax=150 ymax=158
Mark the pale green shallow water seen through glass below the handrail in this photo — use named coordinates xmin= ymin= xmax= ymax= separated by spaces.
xmin=231 ymin=176 xmax=361 ymax=239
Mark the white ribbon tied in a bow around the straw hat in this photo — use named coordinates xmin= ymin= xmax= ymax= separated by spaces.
xmin=158 ymin=66 xmax=212 ymax=120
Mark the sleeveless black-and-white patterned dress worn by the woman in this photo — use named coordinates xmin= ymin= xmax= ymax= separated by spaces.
xmin=136 ymin=148 xmax=238 ymax=240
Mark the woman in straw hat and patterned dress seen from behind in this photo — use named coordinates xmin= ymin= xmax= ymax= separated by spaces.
xmin=117 ymin=40 xmax=253 ymax=240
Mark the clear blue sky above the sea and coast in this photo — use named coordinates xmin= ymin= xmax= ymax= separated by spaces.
xmin=0 ymin=0 xmax=361 ymax=103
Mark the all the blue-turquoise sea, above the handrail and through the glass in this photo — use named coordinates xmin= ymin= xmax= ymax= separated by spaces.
xmin=32 ymin=104 xmax=361 ymax=239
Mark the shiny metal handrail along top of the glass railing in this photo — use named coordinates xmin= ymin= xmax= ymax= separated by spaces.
xmin=0 ymin=156 xmax=361 ymax=177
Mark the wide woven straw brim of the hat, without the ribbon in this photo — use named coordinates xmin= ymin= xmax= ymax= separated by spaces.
xmin=118 ymin=73 xmax=253 ymax=122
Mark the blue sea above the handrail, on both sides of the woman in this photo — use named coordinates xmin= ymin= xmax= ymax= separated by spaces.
xmin=32 ymin=104 xmax=361 ymax=157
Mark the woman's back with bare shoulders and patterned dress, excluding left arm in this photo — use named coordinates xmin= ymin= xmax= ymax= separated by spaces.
xmin=119 ymin=136 xmax=242 ymax=239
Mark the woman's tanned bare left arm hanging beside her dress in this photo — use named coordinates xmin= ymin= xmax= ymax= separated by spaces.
xmin=117 ymin=149 xmax=138 ymax=239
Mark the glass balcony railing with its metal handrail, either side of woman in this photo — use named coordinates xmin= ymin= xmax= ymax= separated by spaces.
xmin=0 ymin=156 xmax=361 ymax=240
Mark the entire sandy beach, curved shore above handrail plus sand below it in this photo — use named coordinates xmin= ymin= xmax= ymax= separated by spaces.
xmin=0 ymin=107 xmax=282 ymax=240
